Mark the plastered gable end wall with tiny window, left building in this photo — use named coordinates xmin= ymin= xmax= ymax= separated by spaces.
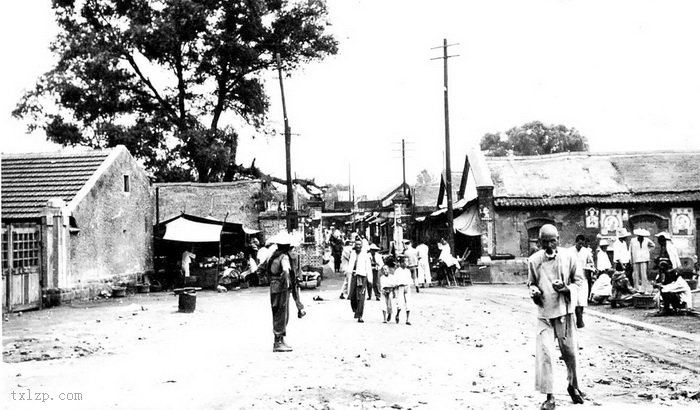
xmin=69 ymin=152 xmax=153 ymax=289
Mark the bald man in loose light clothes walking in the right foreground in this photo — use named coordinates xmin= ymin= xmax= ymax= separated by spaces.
xmin=528 ymin=224 xmax=583 ymax=410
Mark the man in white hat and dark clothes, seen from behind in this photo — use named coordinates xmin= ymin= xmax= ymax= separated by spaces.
xmin=268 ymin=232 xmax=302 ymax=352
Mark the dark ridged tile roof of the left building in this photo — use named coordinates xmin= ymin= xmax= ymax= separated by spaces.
xmin=2 ymin=150 xmax=111 ymax=219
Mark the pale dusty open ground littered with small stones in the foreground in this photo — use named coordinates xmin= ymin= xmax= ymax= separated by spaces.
xmin=0 ymin=280 xmax=700 ymax=409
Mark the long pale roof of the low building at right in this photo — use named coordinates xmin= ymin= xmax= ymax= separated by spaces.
xmin=486 ymin=152 xmax=700 ymax=206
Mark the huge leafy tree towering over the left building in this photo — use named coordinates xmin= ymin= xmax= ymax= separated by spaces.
xmin=13 ymin=0 xmax=337 ymax=182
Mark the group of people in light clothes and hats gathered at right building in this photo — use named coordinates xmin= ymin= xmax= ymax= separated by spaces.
xmin=589 ymin=229 xmax=692 ymax=315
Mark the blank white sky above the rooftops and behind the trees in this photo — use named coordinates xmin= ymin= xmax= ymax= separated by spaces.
xmin=0 ymin=0 xmax=700 ymax=197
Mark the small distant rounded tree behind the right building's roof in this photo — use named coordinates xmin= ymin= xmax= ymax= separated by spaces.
xmin=480 ymin=121 xmax=588 ymax=156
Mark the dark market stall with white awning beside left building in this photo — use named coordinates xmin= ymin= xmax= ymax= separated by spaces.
xmin=154 ymin=213 xmax=258 ymax=289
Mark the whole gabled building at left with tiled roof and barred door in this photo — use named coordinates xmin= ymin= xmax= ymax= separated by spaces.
xmin=2 ymin=146 xmax=153 ymax=311
